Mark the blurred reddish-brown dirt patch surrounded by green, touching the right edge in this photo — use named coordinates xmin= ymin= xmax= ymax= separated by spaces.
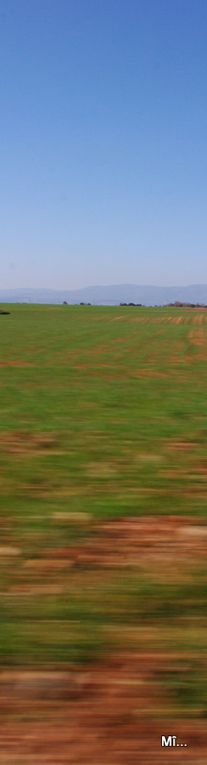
xmin=42 ymin=516 xmax=207 ymax=578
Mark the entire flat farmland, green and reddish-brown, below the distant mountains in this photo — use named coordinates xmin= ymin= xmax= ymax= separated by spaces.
xmin=0 ymin=305 xmax=207 ymax=765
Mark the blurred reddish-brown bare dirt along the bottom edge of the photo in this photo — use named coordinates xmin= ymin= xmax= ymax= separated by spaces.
xmin=0 ymin=655 xmax=207 ymax=765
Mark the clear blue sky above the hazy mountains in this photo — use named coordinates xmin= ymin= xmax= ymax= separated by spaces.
xmin=0 ymin=0 xmax=207 ymax=289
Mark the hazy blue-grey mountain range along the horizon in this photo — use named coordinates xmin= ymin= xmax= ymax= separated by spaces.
xmin=0 ymin=284 xmax=207 ymax=306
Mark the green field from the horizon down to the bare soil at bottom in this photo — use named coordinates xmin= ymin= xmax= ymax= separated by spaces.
xmin=0 ymin=305 xmax=207 ymax=716
